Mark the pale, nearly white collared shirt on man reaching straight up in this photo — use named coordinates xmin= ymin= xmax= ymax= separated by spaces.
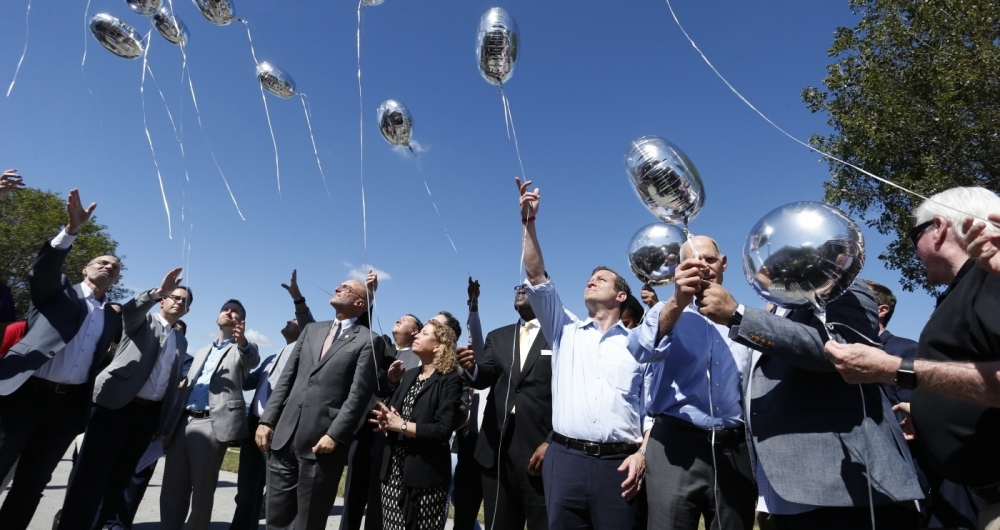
xmin=524 ymin=281 xmax=653 ymax=443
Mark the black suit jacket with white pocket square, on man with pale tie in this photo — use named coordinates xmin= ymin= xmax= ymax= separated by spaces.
xmin=472 ymin=324 xmax=552 ymax=468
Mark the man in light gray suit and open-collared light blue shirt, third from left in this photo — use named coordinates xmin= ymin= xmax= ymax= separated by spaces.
xmin=160 ymin=300 xmax=260 ymax=530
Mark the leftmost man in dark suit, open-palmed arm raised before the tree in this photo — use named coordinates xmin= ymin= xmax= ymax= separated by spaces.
xmin=0 ymin=189 xmax=121 ymax=530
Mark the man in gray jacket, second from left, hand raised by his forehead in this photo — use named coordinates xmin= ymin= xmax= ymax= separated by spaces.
xmin=59 ymin=268 xmax=194 ymax=530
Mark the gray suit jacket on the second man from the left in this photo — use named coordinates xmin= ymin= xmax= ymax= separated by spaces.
xmin=94 ymin=290 xmax=187 ymax=432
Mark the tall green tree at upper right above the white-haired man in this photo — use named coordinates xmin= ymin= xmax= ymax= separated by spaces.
xmin=802 ymin=0 xmax=1000 ymax=292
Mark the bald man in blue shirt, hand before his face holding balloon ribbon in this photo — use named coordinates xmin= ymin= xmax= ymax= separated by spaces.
xmin=629 ymin=236 xmax=757 ymax=530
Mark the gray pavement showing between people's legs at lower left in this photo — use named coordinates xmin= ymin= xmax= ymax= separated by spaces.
xmin=0 ymin=448 xmax=452 ymax=530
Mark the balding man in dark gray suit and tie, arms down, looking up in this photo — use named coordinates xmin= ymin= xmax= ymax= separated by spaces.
xmin=256 ymin=280 xmax=377 ymax=530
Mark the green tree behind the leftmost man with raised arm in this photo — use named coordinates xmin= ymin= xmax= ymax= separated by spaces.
xmin=0 ymin=188 xmax=132 ymax=319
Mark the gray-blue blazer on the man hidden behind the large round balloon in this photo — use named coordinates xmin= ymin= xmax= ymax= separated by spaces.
xmin=730 ymin=283 xmax=923 ymax=506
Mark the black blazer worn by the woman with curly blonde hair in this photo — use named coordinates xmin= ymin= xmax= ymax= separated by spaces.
xmin=379 ymin=368 xmax=466 ymax=489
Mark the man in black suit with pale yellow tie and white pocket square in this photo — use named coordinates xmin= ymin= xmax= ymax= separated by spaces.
xmin=459 ymin=285 xmax=552 ymax=530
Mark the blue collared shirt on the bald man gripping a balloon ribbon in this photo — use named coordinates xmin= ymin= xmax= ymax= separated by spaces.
xmin=628 ymin=302 xmax=750 ymax=430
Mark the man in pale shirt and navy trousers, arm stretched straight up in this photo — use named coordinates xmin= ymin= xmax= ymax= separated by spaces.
xmin=516 ymin=179 xmax=652 ymax=529
